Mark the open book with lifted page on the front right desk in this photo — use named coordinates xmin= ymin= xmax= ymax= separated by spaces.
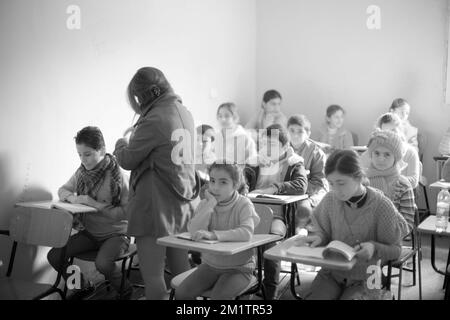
xmin=287 ymin=240 xmax=356 ymax=261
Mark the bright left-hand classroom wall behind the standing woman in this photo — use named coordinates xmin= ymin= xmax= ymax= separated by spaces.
xmin=0 ymin=0 xmax=256 ymax=281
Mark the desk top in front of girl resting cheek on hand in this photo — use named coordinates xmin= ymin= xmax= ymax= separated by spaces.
xmin=156 ymin=234 xmax=282 ymax=255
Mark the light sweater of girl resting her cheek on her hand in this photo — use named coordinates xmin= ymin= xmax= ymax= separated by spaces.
xmin=188 ymin=192 xmax=260 ymax=272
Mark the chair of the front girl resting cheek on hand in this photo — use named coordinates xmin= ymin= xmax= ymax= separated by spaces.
xmin=169 ymin=204 xmax=273 ymax=300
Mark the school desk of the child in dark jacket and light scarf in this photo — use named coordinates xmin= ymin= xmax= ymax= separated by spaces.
xmin=248 ymin=193 xmax=308 ymax=299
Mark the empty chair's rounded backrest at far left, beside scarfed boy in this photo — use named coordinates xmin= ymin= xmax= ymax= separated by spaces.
xmin=9 ymin=208 xmax=73 ymax=248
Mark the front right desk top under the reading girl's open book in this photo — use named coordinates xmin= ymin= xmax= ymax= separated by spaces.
xmin=264 ymin=235 xmax=356 ymax=271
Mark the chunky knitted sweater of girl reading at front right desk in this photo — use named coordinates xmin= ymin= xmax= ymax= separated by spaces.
xmin=312 ymin=187 xmax=406 ymax=280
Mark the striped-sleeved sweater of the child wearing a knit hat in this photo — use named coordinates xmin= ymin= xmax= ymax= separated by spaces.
xmin=367 ymin=166 xmax=415 ymax=236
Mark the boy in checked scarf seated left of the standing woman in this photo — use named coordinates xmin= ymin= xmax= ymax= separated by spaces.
xmin=47 ymin=127 xmax=132 ymax=299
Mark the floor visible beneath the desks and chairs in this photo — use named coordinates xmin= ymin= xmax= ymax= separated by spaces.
xmin=83 ymin=232 xmax=450 ymax=300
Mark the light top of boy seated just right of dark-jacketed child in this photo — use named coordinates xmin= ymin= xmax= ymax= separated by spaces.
xmin=294 ymin=139 xmax=329 ymax=207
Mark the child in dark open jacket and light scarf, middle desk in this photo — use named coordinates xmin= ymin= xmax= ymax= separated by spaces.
xmin=244 ymin=124 xmax=308 ymax=299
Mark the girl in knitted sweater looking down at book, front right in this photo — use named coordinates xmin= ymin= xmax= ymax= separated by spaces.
xmin=296 ymin=150 xmax=406 ymax=300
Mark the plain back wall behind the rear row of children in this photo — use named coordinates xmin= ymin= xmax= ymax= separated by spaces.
xmin=255 ymin=0 xmax=450 ymax=185
